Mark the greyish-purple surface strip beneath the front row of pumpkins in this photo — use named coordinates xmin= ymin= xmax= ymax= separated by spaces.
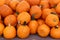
xmin=0 ymin=35 xmax=60 ymax=40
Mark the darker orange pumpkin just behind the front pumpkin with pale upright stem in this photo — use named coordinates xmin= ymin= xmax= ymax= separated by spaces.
xmin=4 ymin=15 xmax=17 ymax=26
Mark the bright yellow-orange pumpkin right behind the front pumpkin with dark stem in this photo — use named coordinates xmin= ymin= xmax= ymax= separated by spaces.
xmin=17 ymin=12 xmax=31 ymax=24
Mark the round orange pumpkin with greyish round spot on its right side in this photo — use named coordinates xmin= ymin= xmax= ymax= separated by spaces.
xmin=45 ymin=14 xmax=59 ymax=27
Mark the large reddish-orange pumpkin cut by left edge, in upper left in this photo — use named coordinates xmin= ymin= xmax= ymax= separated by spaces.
xmin=0 ymin=5 xmax=13 ymax=17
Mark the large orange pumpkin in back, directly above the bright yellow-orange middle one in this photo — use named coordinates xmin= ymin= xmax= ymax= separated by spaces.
xmin=16 ymin=1 xmax=30 ymax=13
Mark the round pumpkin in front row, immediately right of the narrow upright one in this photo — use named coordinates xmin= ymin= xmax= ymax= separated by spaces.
xmin=37 ymin=24 xmax=50 ymax=37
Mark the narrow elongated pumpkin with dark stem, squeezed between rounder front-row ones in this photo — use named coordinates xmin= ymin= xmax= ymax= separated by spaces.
xmin=28 ymin=17 xmax=38 ymax=34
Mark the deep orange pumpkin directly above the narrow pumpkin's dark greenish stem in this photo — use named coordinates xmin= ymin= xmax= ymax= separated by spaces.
xmin=30 ymin=5 xmax=42 ymax=19
